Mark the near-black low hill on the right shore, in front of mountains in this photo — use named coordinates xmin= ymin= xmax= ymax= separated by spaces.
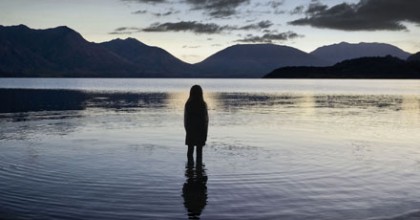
xmin=265 ymin=56 xmax=420 ymax=79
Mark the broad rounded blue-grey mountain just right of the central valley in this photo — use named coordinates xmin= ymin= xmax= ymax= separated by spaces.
xmin=195 ymin=44 xmax=327 ymax=78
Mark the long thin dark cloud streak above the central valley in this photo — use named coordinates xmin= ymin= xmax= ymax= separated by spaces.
xmin=142 ymin=20 xmax=273 ymax=34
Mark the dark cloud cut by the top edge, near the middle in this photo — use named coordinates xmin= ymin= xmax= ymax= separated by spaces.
xmin=185 ymin=0 xmax=250 ymax=18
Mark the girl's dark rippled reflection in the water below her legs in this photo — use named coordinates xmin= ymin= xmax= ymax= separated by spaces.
xmin=182 ymin=161 xmax=208 ymax=219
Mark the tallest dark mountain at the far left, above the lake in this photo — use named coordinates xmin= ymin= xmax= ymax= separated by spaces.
xmin=0 ymin=25 xmax=138 ymax=77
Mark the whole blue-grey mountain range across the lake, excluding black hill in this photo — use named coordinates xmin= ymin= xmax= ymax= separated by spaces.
xmin=0 ymin=25 xmax=419 ymax=78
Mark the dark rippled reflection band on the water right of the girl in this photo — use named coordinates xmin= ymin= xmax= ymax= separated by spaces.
xmin=216 ymin=93 xmax=420 ymax=111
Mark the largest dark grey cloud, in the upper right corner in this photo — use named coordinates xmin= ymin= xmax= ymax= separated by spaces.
xmin=289 ymin=0 xmax=420 ymax=31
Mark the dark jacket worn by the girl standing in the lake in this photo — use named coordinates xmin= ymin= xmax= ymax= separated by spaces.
xmin=184 ymin=100 xmax=209 ymax=146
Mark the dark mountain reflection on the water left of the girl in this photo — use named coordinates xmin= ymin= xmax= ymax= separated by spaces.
xmin=0 ymin=89 xmax=168 ymax=113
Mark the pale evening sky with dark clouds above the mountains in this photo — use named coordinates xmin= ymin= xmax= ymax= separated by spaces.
xmin=0 ymin=0 xmax=420 ymax=63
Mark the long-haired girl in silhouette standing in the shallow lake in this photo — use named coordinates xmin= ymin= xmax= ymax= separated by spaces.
xmin=184 ymin=85 xmax=209 ymax=161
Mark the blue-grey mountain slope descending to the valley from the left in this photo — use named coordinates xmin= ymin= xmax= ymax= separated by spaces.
xmin=100 ymin=38 xmax=196 ymax=77
